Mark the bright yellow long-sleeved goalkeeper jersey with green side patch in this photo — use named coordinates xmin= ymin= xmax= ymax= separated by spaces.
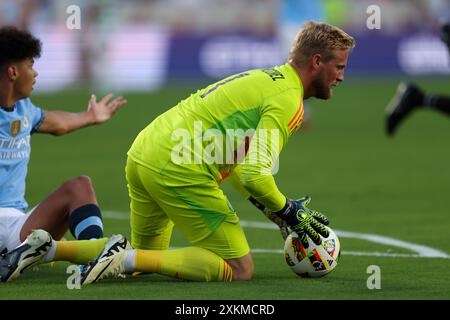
xmin=128 ymin=64 xmax=304 ymax=211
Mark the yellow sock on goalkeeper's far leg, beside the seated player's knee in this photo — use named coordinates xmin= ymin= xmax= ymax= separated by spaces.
xmin=52 ymin=238 xmax=108 ymax=264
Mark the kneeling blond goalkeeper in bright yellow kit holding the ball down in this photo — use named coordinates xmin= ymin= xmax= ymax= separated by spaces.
xmin=82 ymin=22 xmax=355 ymax=284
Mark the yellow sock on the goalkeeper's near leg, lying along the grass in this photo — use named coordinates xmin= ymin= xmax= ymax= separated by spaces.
xmin=134 ymin=247 xmax=233 ymax=281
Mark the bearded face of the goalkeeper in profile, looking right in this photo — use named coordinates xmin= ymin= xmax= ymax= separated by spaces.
xmin=312 ymin=49 xmax=349 ymax=99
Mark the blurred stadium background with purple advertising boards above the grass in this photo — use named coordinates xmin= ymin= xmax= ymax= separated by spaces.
xmin=0 ymin=0 xmax=450 ymax=92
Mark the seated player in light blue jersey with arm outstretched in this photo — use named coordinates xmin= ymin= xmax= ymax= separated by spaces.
xmin=0 ymin=27 xmax=126 ymax=277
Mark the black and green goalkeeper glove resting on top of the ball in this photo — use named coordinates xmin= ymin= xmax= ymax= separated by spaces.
xmin=275 ymin=196 xmax=329 ymax=248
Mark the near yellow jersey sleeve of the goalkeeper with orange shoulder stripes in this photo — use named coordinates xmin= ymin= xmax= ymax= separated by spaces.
xmin=237 ymin=89 xmax=303 ymax=212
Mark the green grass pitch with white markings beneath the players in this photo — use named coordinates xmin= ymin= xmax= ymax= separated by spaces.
xmin=0 ymin=77 xmax=450 ymax=300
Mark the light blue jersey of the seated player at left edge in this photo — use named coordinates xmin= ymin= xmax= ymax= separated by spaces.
xmin=0 ymin=98 xmax=44 ymax=212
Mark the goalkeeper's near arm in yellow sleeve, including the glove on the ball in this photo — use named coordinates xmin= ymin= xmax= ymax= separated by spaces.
xmin=236 ymin=95 xmax=328 ymax=247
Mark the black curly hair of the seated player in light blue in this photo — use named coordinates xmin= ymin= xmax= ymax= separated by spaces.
xmin=0 ymin=26 xmax=42 ymax=67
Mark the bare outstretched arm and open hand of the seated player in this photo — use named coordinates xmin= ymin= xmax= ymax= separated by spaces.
xmin=37 ymin=94 xmax=127 ymax=136
